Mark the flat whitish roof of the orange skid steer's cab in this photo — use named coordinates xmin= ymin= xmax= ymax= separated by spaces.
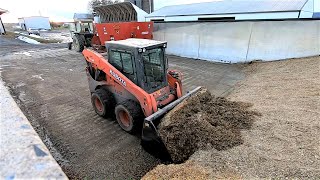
xmin=107 ymin=38 xmax=166 ymax=48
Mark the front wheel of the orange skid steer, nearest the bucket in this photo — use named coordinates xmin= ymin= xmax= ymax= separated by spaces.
xmin=115 ymin=100 xmax=143 ymax=134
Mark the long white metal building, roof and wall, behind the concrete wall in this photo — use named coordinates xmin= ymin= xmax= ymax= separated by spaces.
xmin=146 ymin=0 xmax=320 ymax=21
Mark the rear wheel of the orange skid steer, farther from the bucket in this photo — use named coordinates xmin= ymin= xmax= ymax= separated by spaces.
xmin=91 ymin=88 xmax=115 ymax=118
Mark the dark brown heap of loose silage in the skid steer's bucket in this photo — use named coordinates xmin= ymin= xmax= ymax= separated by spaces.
xmin=158 ymin=88 xmax=259 ymax=163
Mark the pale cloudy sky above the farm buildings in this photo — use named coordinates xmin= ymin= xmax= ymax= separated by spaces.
xmin=0 ymin=0 xmax=218 ymax=23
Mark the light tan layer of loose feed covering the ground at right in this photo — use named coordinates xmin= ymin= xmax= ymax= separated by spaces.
xmin=145 ymin=57 xmax=320 ymax=179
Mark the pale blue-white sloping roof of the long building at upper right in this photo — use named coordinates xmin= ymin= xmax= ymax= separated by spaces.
xmin=147 ymin=0 xmax=308 ymax=17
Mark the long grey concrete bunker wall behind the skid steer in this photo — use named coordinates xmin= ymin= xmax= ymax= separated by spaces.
xmin=153 ymin=20 xmax=320 ymax=63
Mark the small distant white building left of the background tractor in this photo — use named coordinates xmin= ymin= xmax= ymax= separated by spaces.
xmin=18 ymin=16 xmax=51 ymax=30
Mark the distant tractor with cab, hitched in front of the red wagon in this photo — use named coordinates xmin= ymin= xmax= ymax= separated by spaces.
xmin=68 ymin=13 xmax=94 ymax=52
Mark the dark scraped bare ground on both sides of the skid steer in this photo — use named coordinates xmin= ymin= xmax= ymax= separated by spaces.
xmin=0 ymin=36 xmax=245 ymax=179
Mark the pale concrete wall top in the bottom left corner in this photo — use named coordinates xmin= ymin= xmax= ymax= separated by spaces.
xmin=0 ymin=80 xmax=68 ymax=179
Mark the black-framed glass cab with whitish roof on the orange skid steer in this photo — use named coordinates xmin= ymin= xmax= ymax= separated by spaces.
xmin=106 ymin=38 xmax=168 ymax=93
